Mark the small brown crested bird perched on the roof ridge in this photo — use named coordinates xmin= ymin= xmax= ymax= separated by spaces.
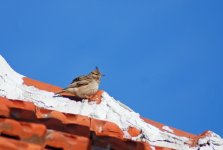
xmin=55 ymin=67 xmax=104 ymax=99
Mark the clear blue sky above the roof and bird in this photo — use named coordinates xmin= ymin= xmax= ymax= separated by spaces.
xmin=0 ymin=0 xmax=223 ymax=136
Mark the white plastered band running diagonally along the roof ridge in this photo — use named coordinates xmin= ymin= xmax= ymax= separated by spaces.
xmin=0 ymin=55 xmax=223 ymax=149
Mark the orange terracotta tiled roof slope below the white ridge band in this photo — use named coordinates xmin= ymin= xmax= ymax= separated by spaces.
xmin=0 ymin=97 xmax=155 ymax=150
